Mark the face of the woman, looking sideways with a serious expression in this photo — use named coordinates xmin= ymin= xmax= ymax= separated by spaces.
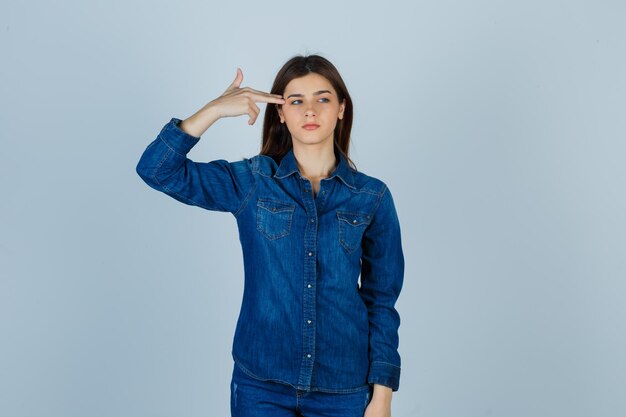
xmin=278 ymin=72 xmax=345 ymax=149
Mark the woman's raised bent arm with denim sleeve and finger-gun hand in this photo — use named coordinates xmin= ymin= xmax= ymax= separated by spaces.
xmin=136 ymin=69 xmax=284 ymax=216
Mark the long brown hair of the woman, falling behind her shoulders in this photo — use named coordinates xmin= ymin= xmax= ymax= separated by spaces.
xmin=260 ymin=55 xmax=356 ymax=170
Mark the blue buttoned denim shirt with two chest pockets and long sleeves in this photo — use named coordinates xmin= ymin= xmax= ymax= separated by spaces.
xmin=136 ymin=118 xmax=404 ymax=393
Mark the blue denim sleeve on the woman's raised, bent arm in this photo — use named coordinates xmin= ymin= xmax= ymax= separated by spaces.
xmin=136 ymin=117 xmax=254 ymax=216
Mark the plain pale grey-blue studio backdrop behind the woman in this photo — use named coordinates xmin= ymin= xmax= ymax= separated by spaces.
xmin=0 ymin=0 xmax=626 ymax=417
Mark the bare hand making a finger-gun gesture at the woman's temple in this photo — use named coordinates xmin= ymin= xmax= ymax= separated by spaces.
xmin=179 ymin=68 xmax=285 ymax=138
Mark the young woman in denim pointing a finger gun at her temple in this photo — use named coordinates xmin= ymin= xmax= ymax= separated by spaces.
xmin=137 ymin=55 xmax=404 ymax=417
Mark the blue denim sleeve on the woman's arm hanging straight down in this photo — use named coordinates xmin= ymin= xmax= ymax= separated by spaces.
xmin=359 ymin=187 xmax=404 ymax=391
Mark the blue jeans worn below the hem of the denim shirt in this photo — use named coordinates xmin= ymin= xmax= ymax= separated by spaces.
xmin=230 ymin=363 xmax=373 ymax=417
